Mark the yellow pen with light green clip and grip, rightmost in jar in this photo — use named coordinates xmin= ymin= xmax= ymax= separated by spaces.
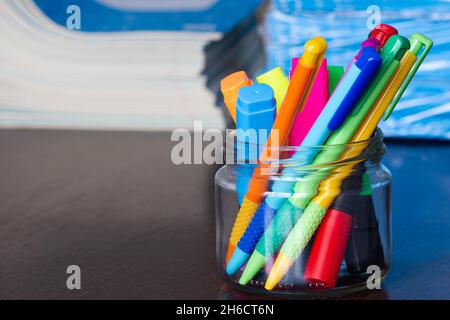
xmin=265 ymin=34 xmax=432 ymax=290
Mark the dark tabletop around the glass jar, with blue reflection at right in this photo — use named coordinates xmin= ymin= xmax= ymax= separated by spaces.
xmin=0 ymin=130 xmax=450 ymax=299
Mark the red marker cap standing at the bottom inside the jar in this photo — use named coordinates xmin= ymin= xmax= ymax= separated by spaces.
xmin=304 ymin=209 xmax=352 ymax=288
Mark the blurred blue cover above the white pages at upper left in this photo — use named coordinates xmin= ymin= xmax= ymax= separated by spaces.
xmin=34 ymin=0 xmax=263 ymax=33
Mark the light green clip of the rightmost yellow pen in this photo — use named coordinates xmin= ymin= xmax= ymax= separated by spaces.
xmin=384 ymin=33 xmax=433 ymax=121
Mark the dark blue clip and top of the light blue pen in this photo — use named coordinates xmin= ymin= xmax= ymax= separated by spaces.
xmin=328 ymin=47 xmax=381 ymax=131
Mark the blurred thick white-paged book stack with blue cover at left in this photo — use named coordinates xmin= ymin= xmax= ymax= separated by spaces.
xmin=0 ymin=0 xmax=264 ymax=130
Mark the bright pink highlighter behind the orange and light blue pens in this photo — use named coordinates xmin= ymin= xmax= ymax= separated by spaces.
xmin=289 ymin=58 xmax=329 ymax=146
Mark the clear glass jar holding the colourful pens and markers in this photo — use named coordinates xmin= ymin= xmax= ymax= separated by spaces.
xmin=215 ymin=129 xmax=391 ymax=297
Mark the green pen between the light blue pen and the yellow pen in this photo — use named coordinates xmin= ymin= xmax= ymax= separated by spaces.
xmin=239 ymin=35 xmax=410 ymax=285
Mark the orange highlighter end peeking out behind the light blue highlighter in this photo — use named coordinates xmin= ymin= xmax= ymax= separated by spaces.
xmin=220 ymin=71 xmax=252 ymax=123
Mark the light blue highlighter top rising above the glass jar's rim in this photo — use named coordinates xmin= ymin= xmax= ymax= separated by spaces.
xmin=236 ymin=84 xmax=276 ymax=138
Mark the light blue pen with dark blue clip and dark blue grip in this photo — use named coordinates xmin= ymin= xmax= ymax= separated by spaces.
xmin=227 ymin=48 xmax=381 ymax=274
